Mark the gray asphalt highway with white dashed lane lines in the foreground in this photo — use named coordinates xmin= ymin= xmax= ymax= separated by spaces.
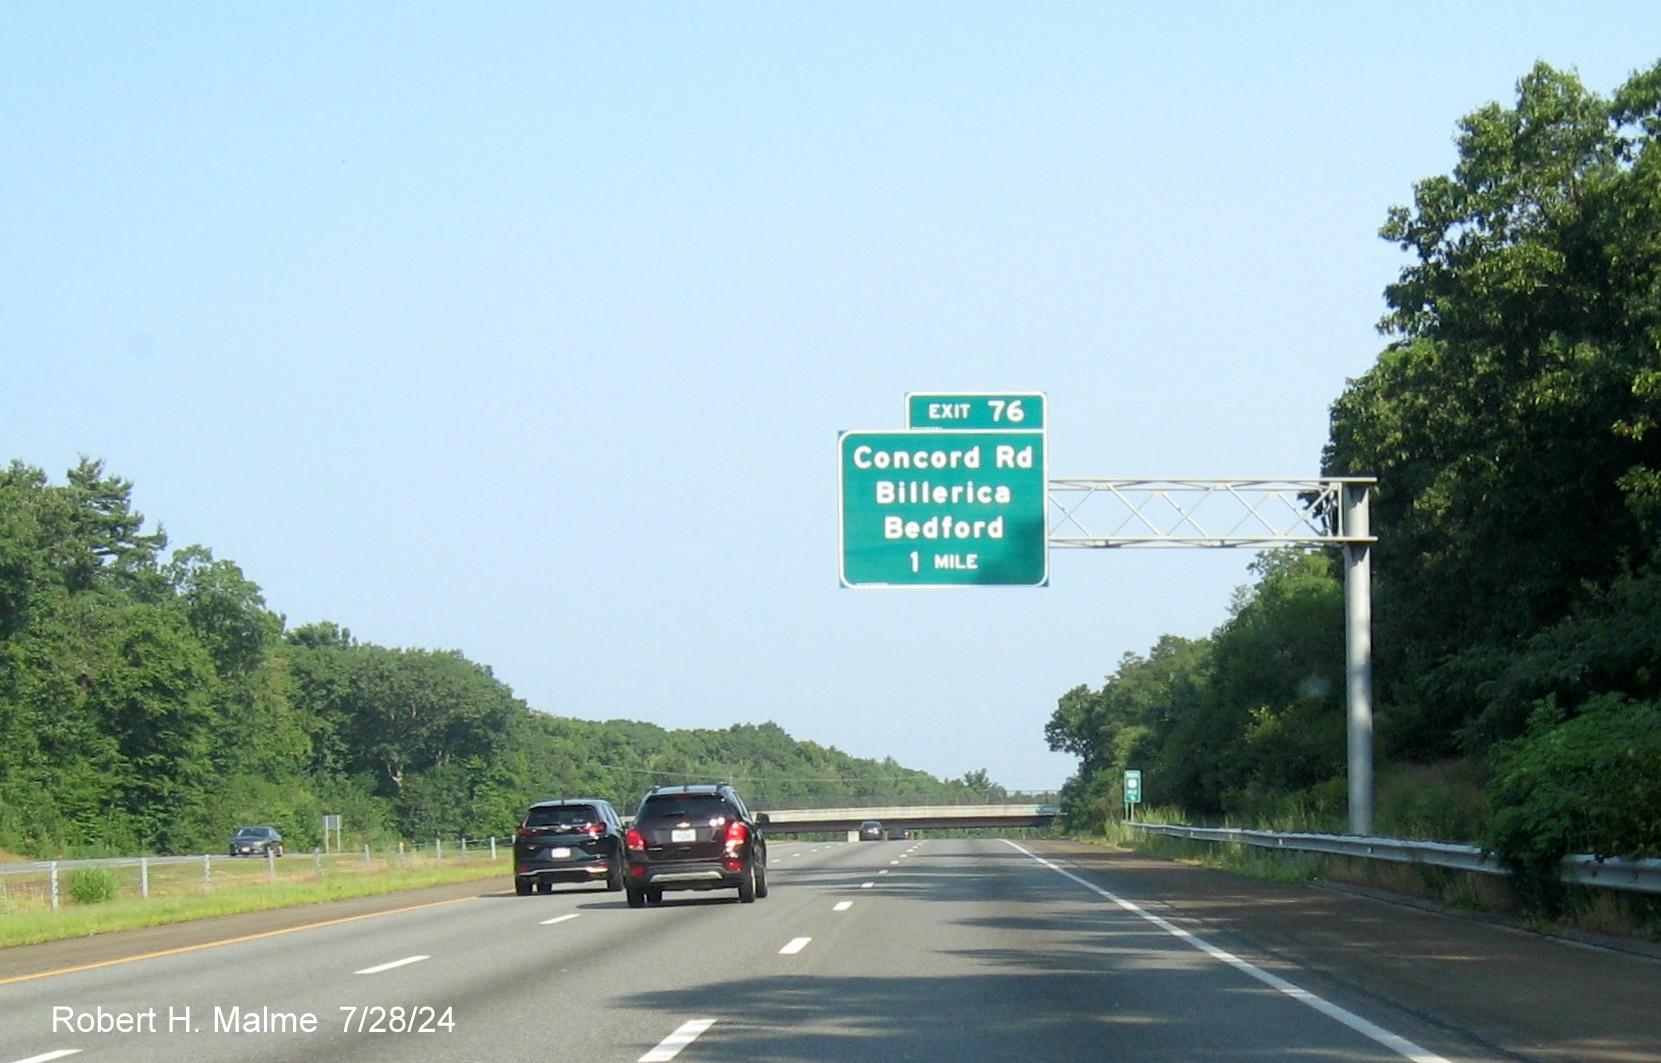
xmin=0 ymin=839 xmax=1661 ymax=1063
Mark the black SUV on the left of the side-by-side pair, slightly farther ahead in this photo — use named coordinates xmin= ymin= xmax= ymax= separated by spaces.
xmin=513 ymin=797 xmax=623 ymax=897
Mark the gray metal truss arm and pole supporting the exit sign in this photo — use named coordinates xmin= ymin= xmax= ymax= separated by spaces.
xmin=1048 ymin=477 xmax=1377 ymax=835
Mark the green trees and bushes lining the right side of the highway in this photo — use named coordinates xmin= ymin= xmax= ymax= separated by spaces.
xmin=1046 ymin=56 xmax=1661 ymax=874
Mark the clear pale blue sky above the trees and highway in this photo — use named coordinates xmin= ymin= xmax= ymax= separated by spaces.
xmin=0 ymin=0 xmax=1661 ymax=789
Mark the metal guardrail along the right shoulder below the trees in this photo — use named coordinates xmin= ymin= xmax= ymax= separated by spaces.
xmin=1124 ymin=822 xmax=1661 ymax=894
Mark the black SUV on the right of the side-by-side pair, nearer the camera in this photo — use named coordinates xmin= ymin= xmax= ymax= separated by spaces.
xmin=625 ymin=782 xmax=767 ymax=909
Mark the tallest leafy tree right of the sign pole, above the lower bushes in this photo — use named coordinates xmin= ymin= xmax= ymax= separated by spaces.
xmin=1324 ymin=63 xmax=1661 ymax=759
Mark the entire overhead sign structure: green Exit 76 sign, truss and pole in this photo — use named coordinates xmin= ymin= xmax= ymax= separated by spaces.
xmin=839 ymin=392 xmax=1377 ymax=834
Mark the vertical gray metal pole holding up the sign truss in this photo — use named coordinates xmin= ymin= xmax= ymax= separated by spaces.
xmin=1344 ymin=483 xmax=1372 ymax=835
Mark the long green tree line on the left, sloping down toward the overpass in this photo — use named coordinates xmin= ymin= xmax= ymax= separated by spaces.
xmin=0 ymin=458 xmax=1005 ymax=857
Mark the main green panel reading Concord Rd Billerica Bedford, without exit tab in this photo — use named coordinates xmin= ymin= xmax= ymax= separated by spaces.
xmin=839 ymin=430 xmax=1050 ymax=586
